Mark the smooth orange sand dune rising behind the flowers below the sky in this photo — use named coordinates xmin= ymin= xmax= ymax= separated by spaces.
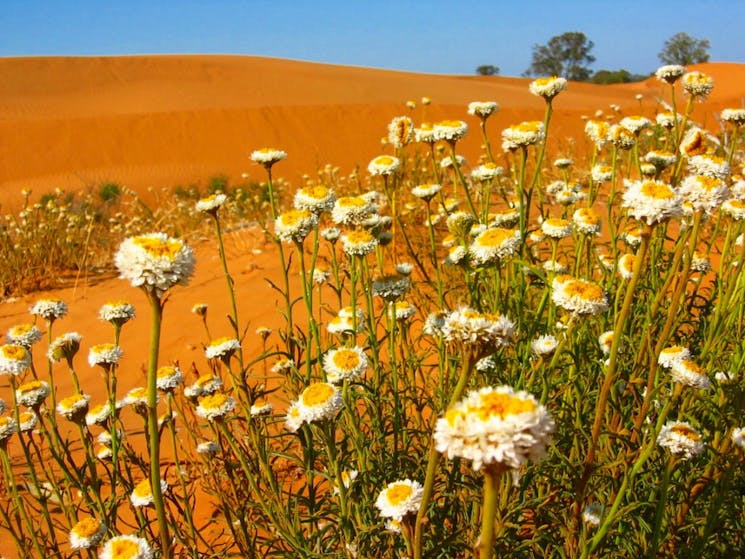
xmin=0 ymin=56 xmax=745 ymax=209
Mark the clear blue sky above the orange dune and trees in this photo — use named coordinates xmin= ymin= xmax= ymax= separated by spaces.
xmin=0 ymin=0 xmax=745 ymax=76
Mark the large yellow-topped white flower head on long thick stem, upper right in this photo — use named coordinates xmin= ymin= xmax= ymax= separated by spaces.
xmin=622 ymin=180 xmax=683 ymax=225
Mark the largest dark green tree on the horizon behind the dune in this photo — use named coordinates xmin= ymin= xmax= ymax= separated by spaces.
xmin=525 ymin=31 xmax=595 ymax=81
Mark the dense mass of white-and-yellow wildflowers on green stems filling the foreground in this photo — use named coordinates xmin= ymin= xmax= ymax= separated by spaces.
xmin=0 ymin=63 xmax=745 ymax=559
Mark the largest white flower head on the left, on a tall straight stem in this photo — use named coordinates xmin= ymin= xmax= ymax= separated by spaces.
xmin=114 ymin=233 xmax=195 ymax=297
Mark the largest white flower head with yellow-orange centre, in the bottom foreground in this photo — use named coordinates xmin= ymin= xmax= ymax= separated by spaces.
xmin=434 ymin=386 xmax=554 ymax=470
